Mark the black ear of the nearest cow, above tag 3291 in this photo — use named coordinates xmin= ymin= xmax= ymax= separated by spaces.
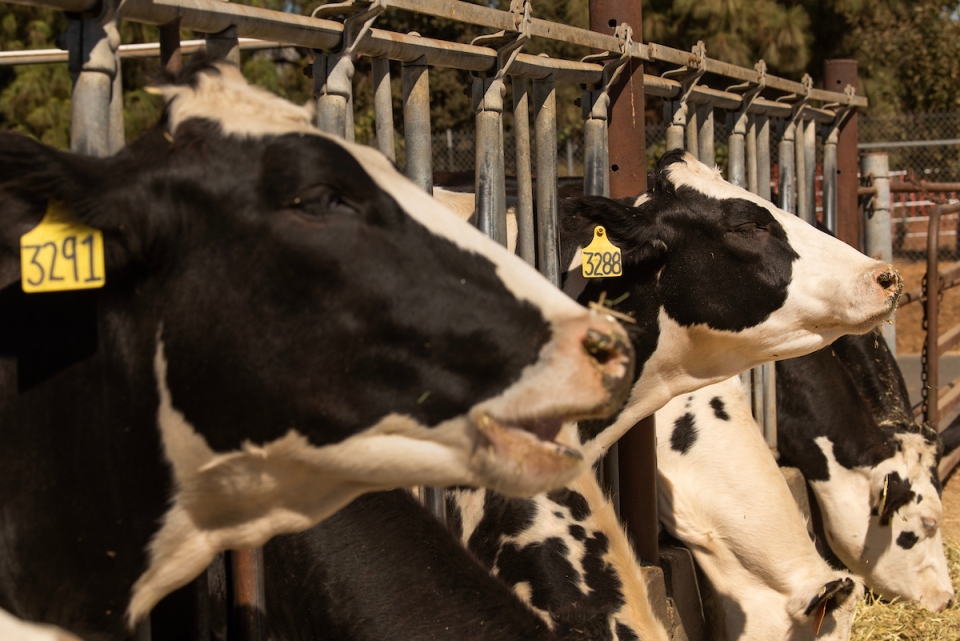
xmin=0 ymin=133 xmax=109 ymax=289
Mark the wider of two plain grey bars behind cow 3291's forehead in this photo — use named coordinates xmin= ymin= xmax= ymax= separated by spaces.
xmin=401 ymin=57 xmax=434 ymax=194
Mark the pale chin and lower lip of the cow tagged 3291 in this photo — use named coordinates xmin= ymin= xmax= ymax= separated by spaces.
xmin=470 ymin=414 xmax=584 ymax=496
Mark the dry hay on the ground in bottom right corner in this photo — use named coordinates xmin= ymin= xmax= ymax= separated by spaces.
xmin=850 ymin=539 xmax=960 ymax=641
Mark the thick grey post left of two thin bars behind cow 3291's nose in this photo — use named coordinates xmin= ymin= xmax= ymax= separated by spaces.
xmin=473 ymin=77 xmax=507 ymax=247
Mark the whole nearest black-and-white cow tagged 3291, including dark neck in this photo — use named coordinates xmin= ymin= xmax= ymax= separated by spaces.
xmin=0 ymin=64 xmax=632 ymax=639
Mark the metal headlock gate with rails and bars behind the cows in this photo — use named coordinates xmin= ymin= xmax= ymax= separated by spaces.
xmin=0 ymin=0 xmax=867 ymax=640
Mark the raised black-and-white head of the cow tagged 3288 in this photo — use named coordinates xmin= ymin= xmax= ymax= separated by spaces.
xmin=561 ymin=151 xmax=902 ymax=449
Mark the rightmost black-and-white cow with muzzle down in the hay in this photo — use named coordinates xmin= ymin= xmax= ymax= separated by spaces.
xmin=777 ymin=332 xmax=954 ymax=612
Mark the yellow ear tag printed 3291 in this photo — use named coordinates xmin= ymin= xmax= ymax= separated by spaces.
xmin=20 ymin=201 xmax=106 ymax=294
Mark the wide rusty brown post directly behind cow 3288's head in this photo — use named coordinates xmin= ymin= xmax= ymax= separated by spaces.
xmin=590 ymin=0 xmax=656 ymax=563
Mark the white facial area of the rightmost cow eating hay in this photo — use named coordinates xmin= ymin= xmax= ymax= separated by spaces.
xmin=810 ymin=434 xmax=954 ymax=612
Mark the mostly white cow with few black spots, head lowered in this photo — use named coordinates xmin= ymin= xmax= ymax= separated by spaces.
xmin=656 ymin=376 xmax=863 ymax=641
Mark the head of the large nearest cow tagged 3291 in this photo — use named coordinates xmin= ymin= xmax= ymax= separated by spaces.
xmin=0 ymin=65 xmax=632 ymax=621
